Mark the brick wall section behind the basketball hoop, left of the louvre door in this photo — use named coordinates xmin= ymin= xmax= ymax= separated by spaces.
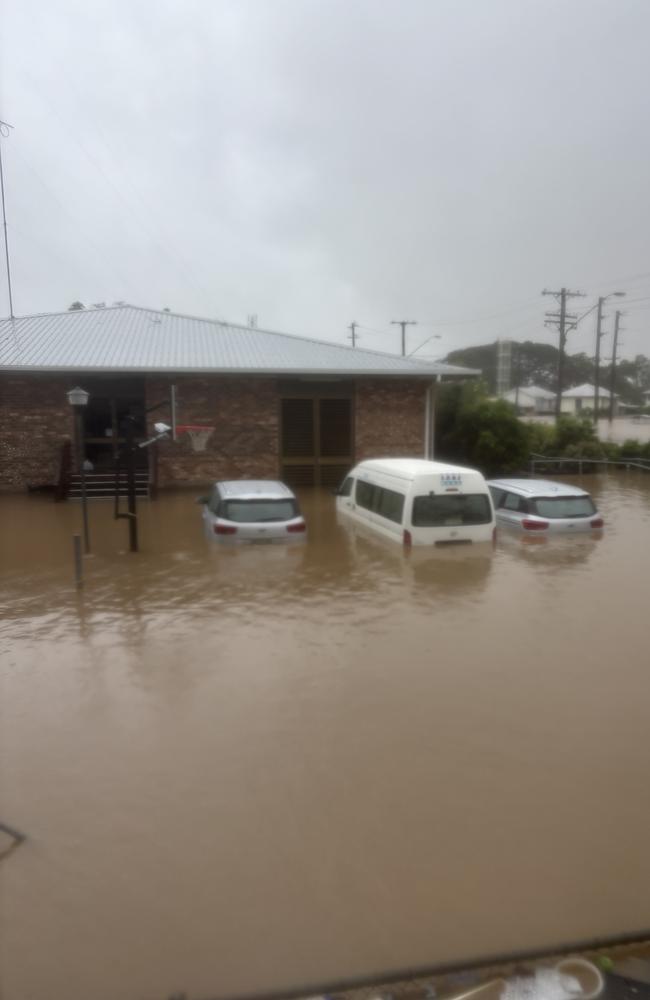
xmin=146 ymin=376 xmax=279 ymax=487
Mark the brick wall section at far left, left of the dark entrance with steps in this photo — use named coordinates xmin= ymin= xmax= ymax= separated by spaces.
xmin=0 ymin=374 xmax=75 ymax=490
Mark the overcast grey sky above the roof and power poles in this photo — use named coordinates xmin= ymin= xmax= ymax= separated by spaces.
xmin=0 ymin=0 xmax=650 ymax=356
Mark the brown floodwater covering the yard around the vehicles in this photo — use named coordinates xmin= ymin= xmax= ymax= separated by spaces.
xmin=0 ymin=472 xmax=650 ymax=1000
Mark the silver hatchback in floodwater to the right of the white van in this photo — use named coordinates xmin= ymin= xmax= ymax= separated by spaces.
xmin=488 ymin=479 xmax=604 ymax=534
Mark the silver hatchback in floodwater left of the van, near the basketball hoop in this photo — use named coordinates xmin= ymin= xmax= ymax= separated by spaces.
xmin=201 ymin=479 xmax=307 ymax=545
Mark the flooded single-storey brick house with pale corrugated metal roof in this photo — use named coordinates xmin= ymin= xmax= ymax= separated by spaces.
xmin=0 ymin=306 xmax=478 ymax=490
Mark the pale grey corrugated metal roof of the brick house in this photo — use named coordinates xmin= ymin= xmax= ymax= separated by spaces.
xmin=0 ymin=305 xmax=475 ymax=376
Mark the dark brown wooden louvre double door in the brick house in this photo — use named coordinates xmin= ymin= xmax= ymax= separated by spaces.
xmin=281 ymin=390 xmax=353 ymax=486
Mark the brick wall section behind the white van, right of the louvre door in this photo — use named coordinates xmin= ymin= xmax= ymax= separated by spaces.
xmin=355 ymin=379 xmax=427 ymax=462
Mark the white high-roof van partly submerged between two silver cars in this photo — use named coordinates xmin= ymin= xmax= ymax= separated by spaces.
xmin=336 ymin=458 xmax=496 ymax=545
